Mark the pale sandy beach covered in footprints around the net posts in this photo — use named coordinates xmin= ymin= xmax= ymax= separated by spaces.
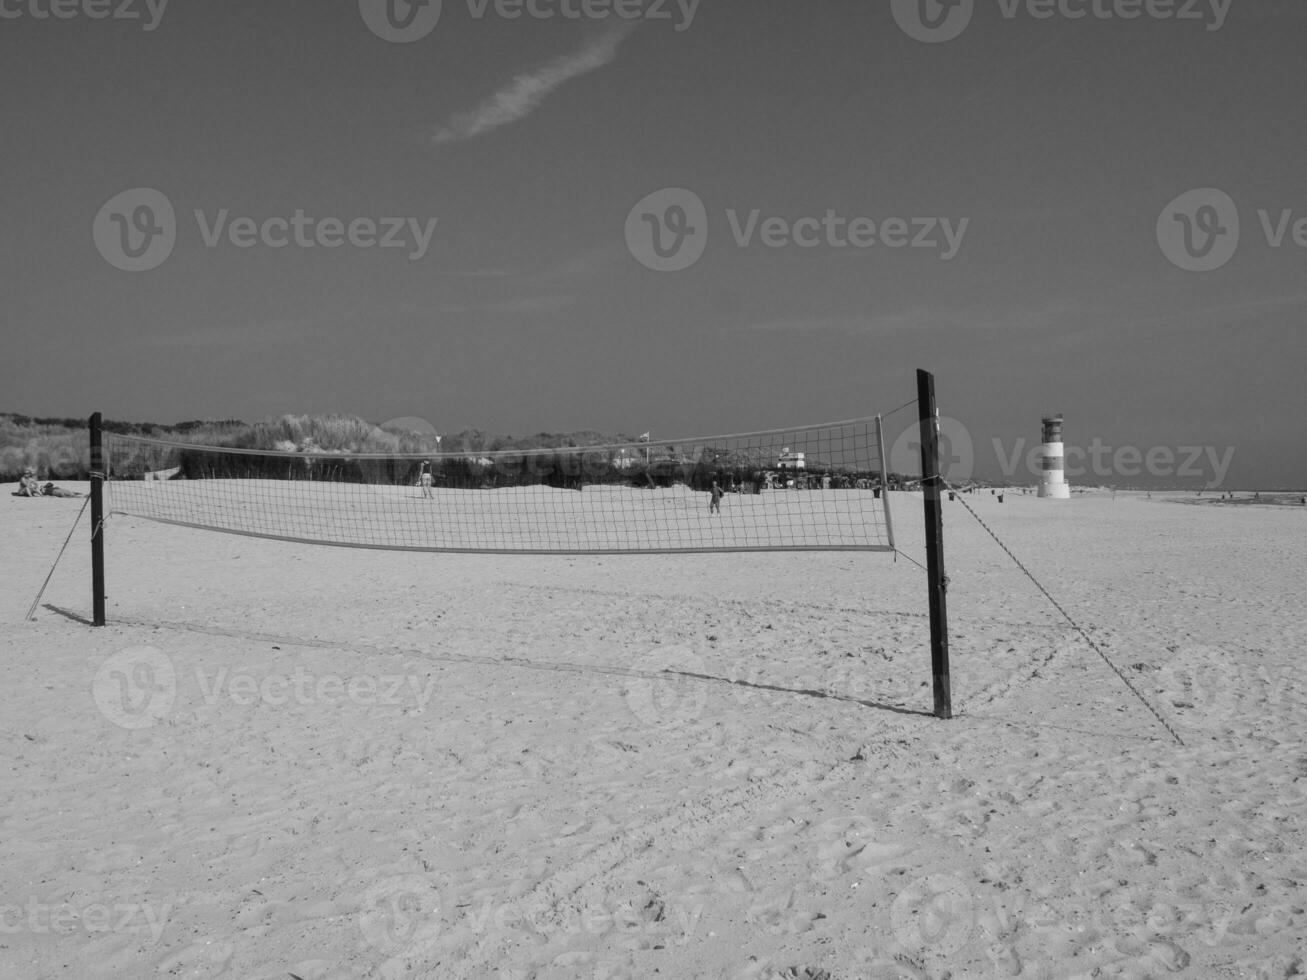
xmin=0 ymin=485 xmax=1307 ymax=980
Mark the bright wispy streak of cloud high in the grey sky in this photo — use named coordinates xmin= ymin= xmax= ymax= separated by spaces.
xmin=431 ymin=21 xmax=637 ymax=145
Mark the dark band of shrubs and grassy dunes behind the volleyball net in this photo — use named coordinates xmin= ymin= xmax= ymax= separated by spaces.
xmin=0 ymin=413 xmax=901 ymax=493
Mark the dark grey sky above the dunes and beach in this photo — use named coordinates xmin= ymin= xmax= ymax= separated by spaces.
xmin=0 ymin=0 xmax=1307 ymax=489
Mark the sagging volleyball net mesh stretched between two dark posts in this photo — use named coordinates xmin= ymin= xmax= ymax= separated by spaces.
xmin=105 ymin=418 xmax=894 ymax=554
